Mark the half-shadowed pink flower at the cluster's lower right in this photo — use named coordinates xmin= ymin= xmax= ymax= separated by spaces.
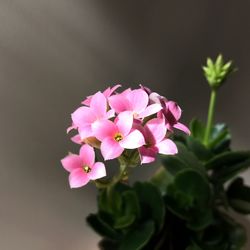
xmin=139 ymin=118 xmax=178 ymax=163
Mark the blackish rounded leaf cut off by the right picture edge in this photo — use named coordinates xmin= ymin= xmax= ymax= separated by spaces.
xmin=227 ymin=177 xmax=250 ymax=214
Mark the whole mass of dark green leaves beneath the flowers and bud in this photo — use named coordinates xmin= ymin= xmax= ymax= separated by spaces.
xmin=87 ymin=120 xmax=250 ymax=250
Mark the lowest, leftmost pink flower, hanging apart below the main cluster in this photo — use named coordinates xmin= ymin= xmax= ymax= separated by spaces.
xmin=61 ymin=145 xmax=106 ymax=188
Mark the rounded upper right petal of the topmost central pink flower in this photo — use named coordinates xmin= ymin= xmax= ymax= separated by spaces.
xmin=127 ymin=89 xmax=149 ymax=114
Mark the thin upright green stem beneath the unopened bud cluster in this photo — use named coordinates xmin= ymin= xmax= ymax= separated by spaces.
xmin=204 ymin=89 xmax=217 ymax=146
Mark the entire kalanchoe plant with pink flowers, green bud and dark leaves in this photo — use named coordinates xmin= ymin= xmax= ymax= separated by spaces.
xmin=62 ymin=55 xmax=250 ymax=250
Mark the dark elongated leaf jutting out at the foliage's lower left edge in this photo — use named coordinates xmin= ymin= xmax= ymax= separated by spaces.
xmin=86 ymin=214 xmax=120 ymax=239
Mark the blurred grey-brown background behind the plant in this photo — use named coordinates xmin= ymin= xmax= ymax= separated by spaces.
xmin=0 ymin=0 xmax=250 ymax=250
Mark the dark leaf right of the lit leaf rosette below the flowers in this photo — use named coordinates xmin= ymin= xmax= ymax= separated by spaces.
xmin=134 ymin=182 xmax=165 ymax=229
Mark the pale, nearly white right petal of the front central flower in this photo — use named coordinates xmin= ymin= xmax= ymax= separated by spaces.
xmin=119 ymin=129 xmax=145 ymax=149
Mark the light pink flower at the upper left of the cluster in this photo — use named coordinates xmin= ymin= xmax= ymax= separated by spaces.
xmin=71 ymin=92 xmax=114 ymax=140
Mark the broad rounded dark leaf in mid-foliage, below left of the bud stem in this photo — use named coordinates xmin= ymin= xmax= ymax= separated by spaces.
xmin=166 ymin=169 xmax=213 ymax=230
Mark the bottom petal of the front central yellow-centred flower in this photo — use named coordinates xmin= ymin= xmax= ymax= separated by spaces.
xmin=101 ymin=138 xmax=124 ymax=160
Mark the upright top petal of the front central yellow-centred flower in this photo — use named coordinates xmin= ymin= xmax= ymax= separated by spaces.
xmin=115 ymin=111 xmax=134 ymax=136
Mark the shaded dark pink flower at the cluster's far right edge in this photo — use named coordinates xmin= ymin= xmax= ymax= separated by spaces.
xmin=159 ymin=101 xmax=190 ymax=135
